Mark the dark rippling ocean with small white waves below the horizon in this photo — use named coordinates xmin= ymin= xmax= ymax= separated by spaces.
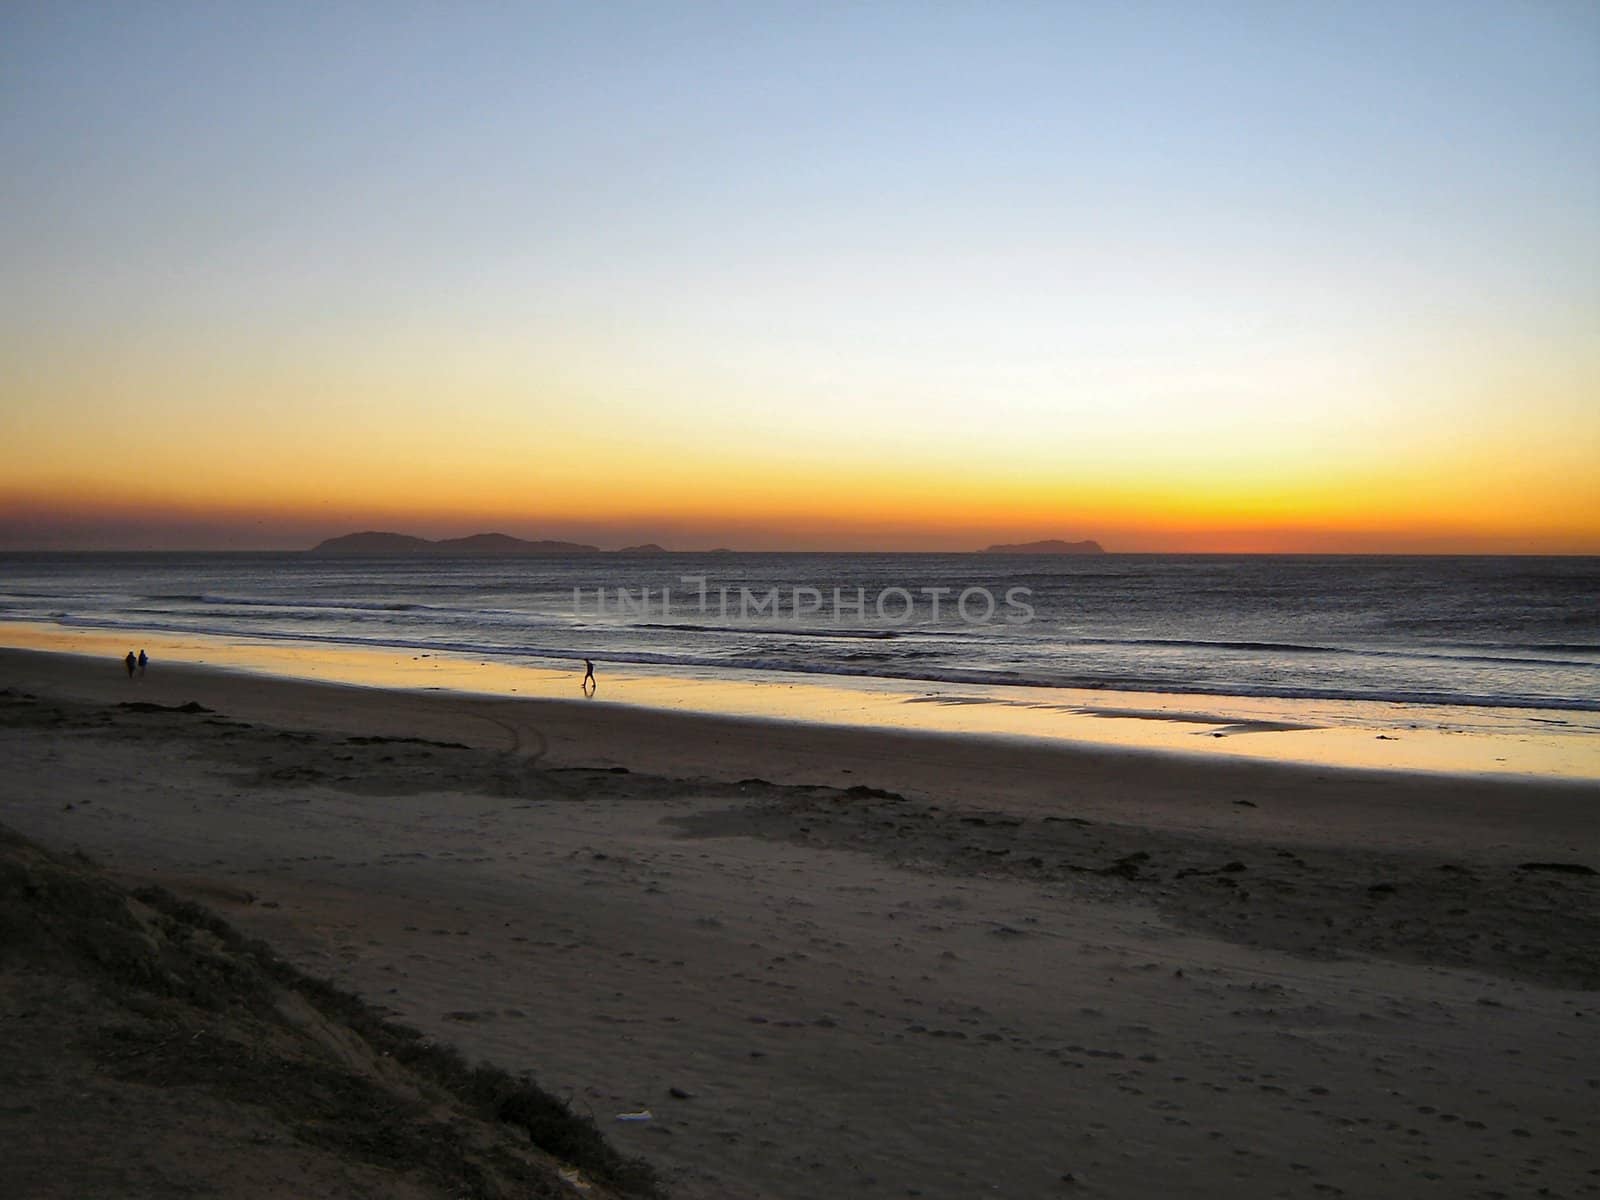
xmin=0 ymin=554 xmax=1600 ymax=712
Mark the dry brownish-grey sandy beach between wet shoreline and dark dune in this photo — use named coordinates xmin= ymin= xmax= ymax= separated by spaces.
xmin=0 ymin=650 xmax=1600 ymax=1200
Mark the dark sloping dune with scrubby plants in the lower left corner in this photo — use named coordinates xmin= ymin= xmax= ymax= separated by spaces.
xmin=0 ymin=826 xmax=659 ymax=1200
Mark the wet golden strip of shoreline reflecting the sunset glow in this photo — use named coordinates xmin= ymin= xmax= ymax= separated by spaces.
xmin=0 ymin=622 xmax=1600 ymax=782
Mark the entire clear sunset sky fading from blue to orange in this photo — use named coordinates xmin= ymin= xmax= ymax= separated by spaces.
xmin=0 ymin=0 xmax=1600 ymax=554
